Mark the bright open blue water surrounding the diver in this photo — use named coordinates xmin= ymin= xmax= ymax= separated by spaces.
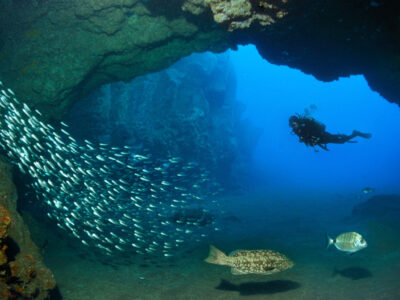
xmin=230 ymin=46 xmax=400 ymax=193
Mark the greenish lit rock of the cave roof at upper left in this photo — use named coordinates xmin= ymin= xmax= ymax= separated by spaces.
xmin=0 ymin=0 xmax=231 ymax=118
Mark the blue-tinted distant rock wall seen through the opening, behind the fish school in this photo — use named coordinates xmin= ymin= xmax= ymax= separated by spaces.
xmin=64 ymin=52 xmax=261 ymax=184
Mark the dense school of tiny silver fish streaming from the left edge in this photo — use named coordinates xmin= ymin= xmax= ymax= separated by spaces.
xmin=0 ymin=82 xmax=220 ymax=257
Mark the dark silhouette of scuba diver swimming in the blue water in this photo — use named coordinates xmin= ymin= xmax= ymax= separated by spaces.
xmin=289 ymin=113 xmax=371 ymax=150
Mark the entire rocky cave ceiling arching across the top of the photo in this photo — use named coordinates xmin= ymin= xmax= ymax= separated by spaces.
xmin=0 ymin=0 xmax=400 ymax=118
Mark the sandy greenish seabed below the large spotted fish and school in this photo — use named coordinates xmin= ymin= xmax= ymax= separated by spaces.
xmin=45 ymin=196 xmax=400 ymax=300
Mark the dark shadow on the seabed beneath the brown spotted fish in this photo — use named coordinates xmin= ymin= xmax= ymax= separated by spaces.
xmin=216 ymin=279 xmax=301 ymax=296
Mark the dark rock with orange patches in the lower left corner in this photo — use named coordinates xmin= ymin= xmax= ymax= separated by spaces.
xmin=0 ymin=161 xmax=56 ymax=299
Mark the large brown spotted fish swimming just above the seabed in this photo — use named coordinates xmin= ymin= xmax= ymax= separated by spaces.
xmin=204 ymin=245 xmax=293 ymax=275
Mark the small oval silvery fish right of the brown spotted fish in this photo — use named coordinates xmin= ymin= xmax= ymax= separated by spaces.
xmin=326 ymin=232 xmax=368 ymax=254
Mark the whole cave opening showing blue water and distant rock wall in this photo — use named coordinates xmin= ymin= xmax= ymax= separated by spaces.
xmin=64 ymin=45 xmax=400 ymax=199
